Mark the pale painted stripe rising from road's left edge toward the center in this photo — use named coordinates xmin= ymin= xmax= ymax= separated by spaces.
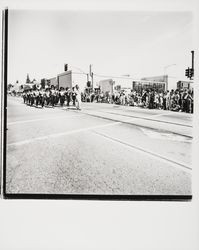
xmin=7 ymin=122 xmax=121 ymax=146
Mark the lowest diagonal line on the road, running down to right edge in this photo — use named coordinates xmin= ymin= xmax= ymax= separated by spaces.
xmin=92 ymin=130 xmax=192 ymax=173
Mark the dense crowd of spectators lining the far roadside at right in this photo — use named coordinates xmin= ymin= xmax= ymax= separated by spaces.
xmin=82 ymin=89 xmax=193 ymax=113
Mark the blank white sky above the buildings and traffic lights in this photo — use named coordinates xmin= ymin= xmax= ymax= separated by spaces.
xmin=8 ymin=10 xmax=193 ymax=89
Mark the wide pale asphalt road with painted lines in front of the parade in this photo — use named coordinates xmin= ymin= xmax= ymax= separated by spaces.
xmin=6 ymin=97 xmax=192 ymax=195
